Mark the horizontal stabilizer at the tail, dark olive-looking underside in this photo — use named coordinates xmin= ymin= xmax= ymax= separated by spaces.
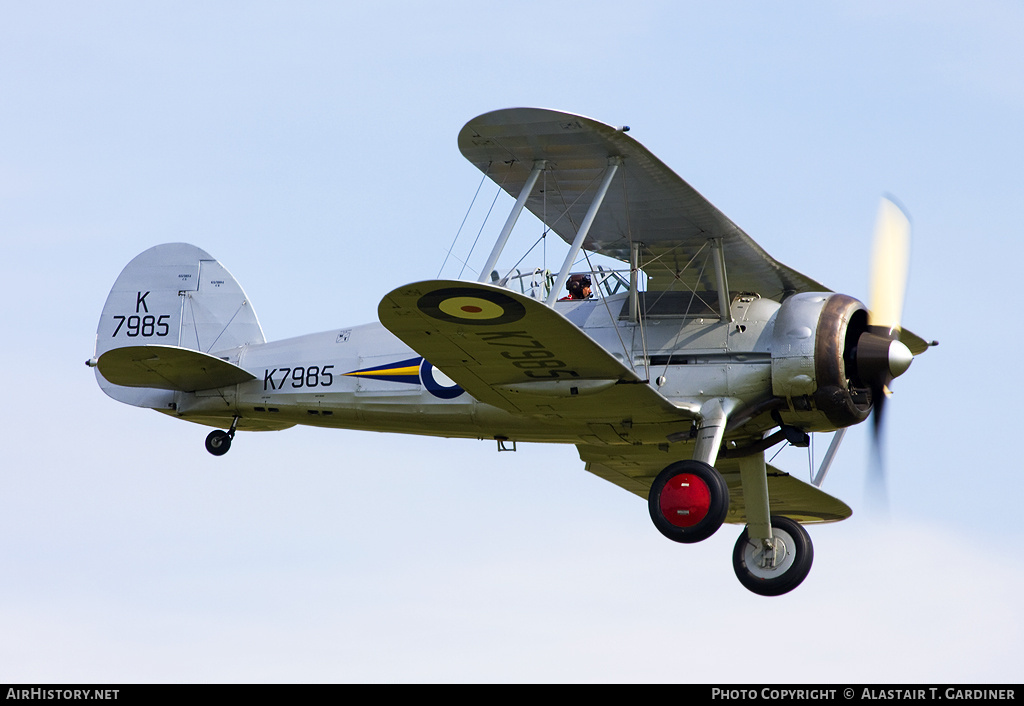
xmin=96 ymin=344 xmax=256 ymax=392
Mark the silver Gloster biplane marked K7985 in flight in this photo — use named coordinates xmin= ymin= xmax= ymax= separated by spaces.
xmin=87 ymin=109 xmax=930 ymax=595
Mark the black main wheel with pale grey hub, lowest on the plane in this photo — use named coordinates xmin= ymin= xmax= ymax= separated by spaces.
xmin=732 ymin=516 xmax=814 ymax=595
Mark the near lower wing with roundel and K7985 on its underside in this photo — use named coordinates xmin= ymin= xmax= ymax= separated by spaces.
xmin=377 ymin=280 xmax=694 ymax=423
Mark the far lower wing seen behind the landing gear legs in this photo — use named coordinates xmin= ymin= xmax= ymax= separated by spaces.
xmin=577 ymin=444 xmax=853 ymax=524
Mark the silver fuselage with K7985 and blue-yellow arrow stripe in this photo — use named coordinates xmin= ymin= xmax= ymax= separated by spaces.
xmin=162 ymin=288 xmax=779 ymax=444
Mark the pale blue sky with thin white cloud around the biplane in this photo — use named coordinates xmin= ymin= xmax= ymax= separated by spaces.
xmin=0 ymin=0 xmax=1024 ymax=684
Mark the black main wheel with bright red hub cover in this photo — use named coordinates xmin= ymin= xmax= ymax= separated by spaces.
xmin=647 ymin=461 xmax=729 ymax=544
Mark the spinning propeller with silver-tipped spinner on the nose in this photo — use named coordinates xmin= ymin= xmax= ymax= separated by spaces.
xmin=854 ymin=199 xmax=913 ymax=506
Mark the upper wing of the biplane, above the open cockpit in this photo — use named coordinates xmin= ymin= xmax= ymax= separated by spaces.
xmin=459 ymin=108 xmax=829 ymax=299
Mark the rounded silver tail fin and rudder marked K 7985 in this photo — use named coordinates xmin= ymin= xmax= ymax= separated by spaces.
xmin=93 ymin=243 xmax=266 ymax=409
